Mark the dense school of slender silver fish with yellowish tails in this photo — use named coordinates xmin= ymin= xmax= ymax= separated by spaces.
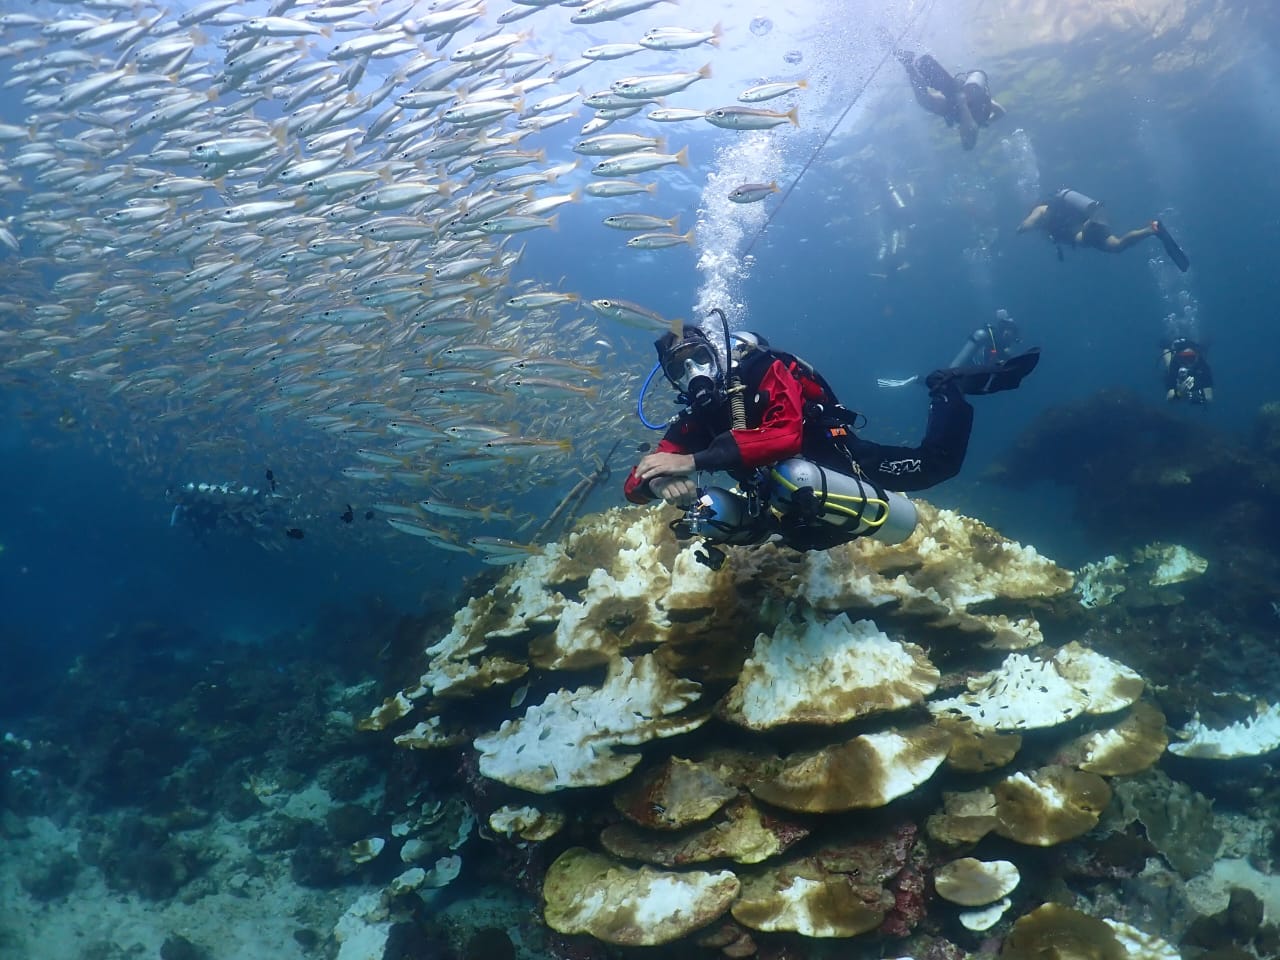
xmin=0 ymin=0 xmax=804 ymax=563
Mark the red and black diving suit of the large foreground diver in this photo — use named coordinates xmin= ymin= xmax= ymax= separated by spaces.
xmin=623 ymin=349 xmax=973 ymax=503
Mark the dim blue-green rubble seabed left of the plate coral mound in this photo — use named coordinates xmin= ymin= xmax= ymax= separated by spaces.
xmin=0 ymin=608 xmax=474 ymax=960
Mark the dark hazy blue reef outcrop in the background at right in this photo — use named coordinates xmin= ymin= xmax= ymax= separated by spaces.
xmin=988 ymin=390 xmax=1280 ymax=627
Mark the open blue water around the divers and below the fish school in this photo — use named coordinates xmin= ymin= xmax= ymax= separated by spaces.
xmin=0 ymin=5 xmax=1280 ymax=701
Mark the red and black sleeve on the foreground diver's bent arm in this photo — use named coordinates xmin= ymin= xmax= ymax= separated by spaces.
xmin=622 ymin=360 xmax=822 ymax=503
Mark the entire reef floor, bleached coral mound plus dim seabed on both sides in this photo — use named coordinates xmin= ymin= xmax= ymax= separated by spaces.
xmin=10 ymin=463 xmax=1280 ymax=960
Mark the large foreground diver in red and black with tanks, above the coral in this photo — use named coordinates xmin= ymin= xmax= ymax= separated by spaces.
xmin=623 ymin=310 xmax=1039 ymax=567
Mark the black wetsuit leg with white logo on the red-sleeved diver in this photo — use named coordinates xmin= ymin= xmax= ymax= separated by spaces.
xmin=849 ymin=383 xmax=973 ymax=490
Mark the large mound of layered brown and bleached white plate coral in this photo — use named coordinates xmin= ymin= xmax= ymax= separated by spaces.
xmin=361 ymin=503 xmax=1280 ymax=960
